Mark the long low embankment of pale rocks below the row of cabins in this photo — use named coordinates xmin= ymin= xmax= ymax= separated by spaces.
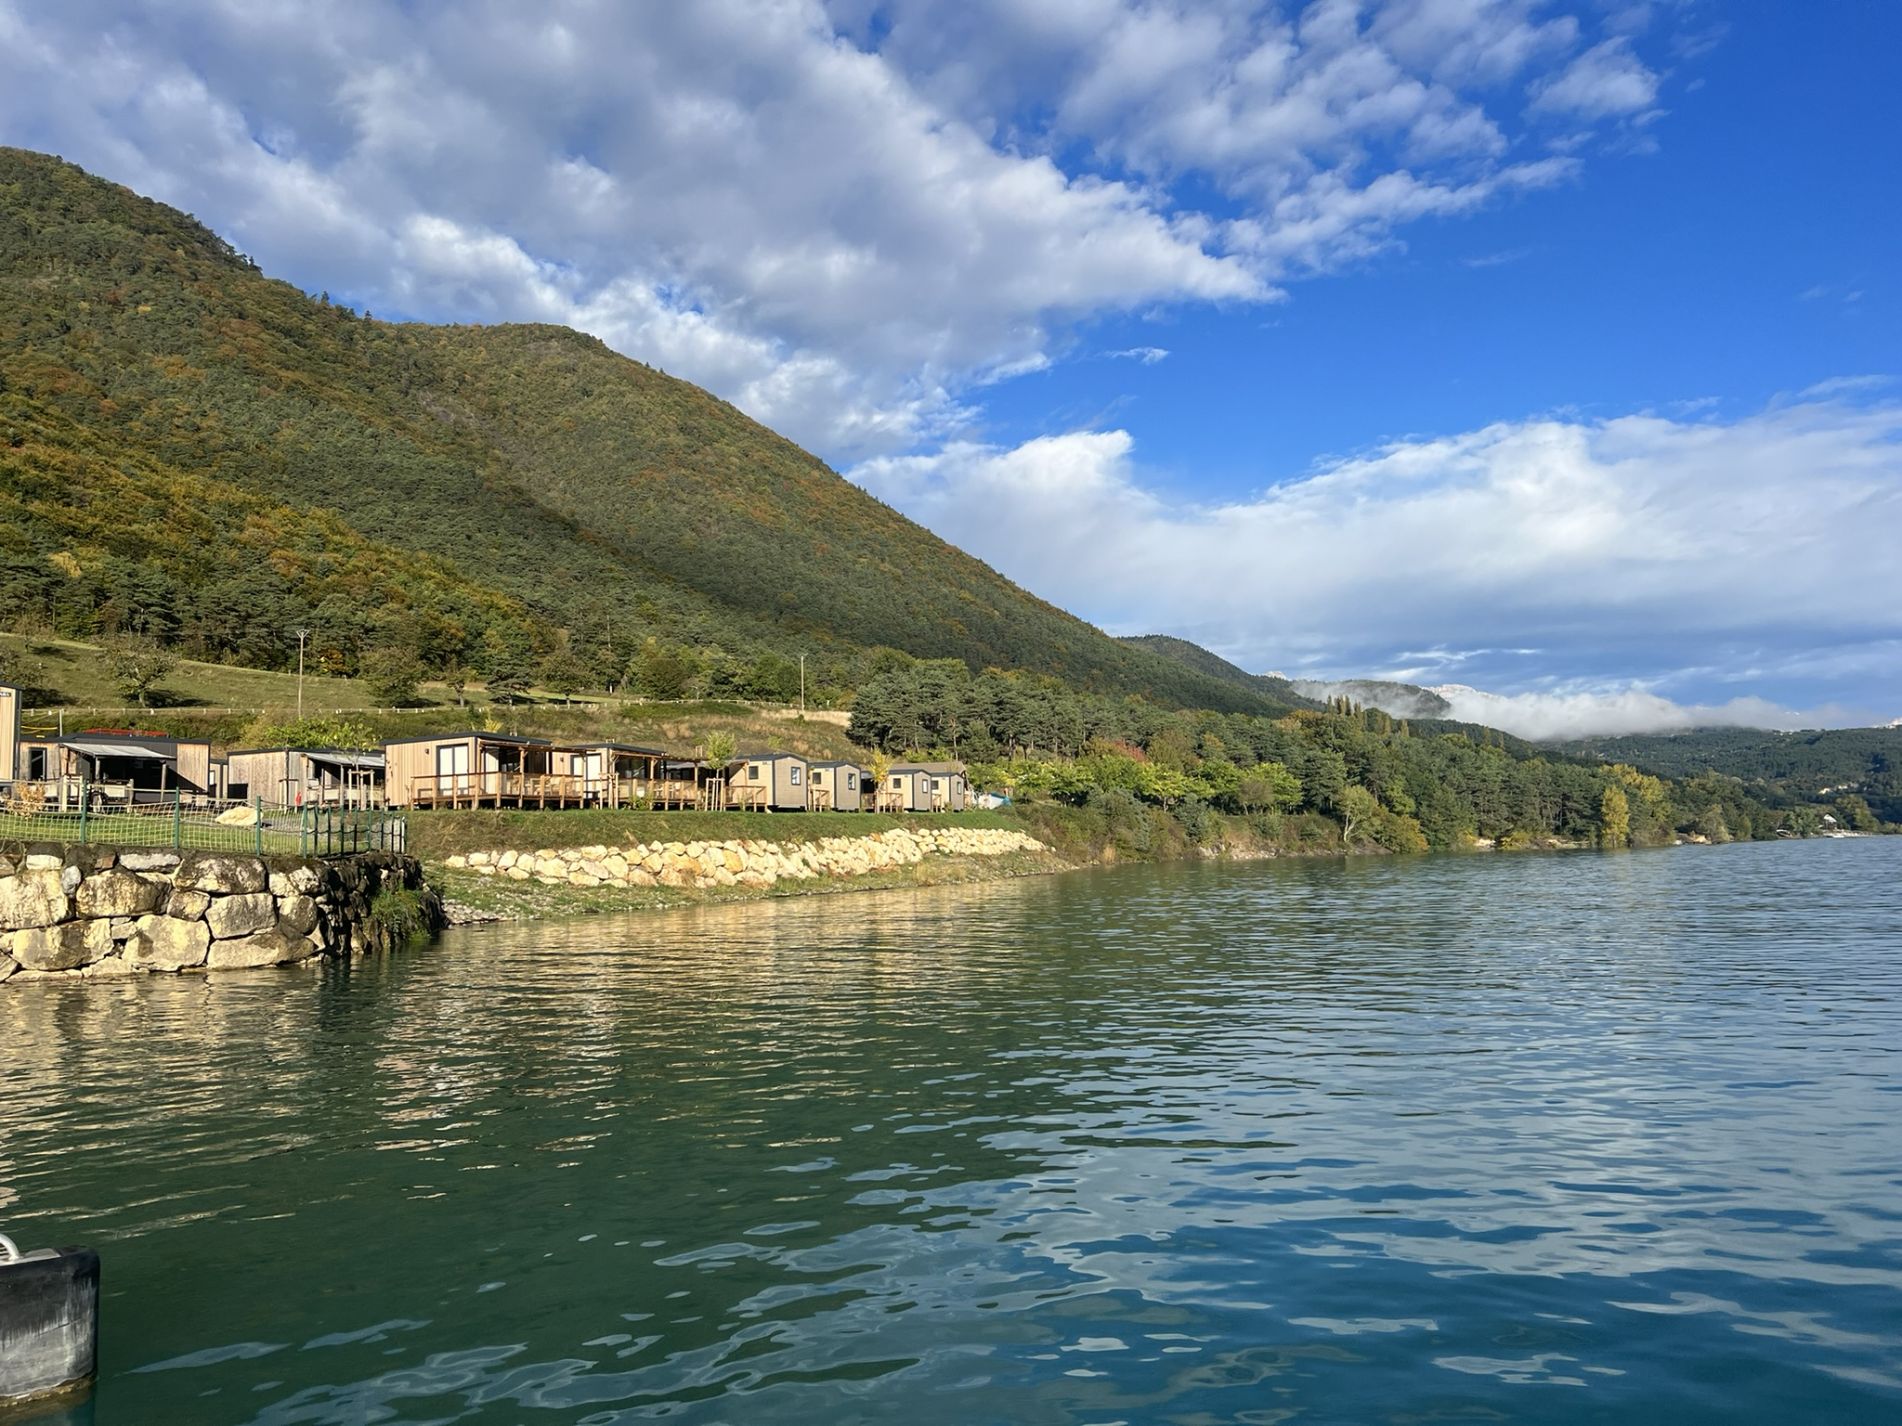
xmin=443 ymin=827 xmax=1048 ymax=886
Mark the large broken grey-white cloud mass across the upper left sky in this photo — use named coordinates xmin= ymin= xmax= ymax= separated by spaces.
xmin=0 ymin=0 xmax=1681 ymax=456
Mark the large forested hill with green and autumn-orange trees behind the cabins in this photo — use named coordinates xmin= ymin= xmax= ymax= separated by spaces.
xmin=0 ymin=148 xmax=1274 ymax=713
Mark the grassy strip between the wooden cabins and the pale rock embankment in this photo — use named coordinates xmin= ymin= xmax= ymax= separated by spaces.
xmin=409 ymin=808 xmax=1021 ymax=861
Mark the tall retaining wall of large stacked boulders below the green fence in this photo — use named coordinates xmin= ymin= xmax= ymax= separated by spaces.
xmin=0 ymin=844 xmax=441 ymax=983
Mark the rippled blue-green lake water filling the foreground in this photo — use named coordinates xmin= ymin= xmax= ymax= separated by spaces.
xmin=0 ymin=838 xmax=1902 ymax=1426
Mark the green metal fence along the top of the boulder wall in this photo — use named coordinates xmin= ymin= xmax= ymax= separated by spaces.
xmin=0 ymin=783 xmax=409 ymax=858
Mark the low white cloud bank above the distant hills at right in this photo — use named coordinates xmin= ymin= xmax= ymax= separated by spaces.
xmin=854 ymin=397 xmax=1902 ymax=718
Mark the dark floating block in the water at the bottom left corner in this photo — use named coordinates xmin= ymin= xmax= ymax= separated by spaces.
xmin=0 ymin=1234 xmax=99 ymax=1405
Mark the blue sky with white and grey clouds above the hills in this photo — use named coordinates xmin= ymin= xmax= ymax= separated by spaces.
xmin=0 ymin=0 xmax=1902 ymax=732
